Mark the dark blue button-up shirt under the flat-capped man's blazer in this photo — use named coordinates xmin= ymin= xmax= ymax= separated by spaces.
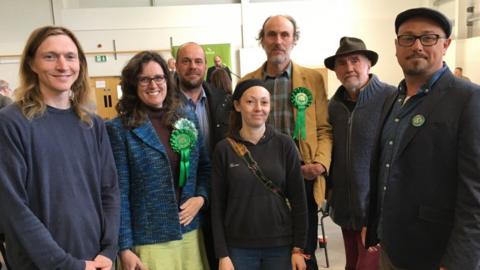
xmin=377 ymin=64 xmax=448 ymax=238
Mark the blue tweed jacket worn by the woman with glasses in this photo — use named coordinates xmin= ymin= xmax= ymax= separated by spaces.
xmin=106 ymin=108 xmax=211 ymax=250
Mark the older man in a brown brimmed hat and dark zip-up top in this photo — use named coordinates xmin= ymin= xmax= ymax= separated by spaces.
xmin=324 ymin=37 xmax=395 ymax=270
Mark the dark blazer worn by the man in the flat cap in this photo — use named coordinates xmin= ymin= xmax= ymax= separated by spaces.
xmin=367 ymin=70 xmax=480 ymax=270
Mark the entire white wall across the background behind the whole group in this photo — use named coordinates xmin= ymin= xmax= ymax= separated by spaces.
xmin=0 ymin=0 xmax=480 ymax=96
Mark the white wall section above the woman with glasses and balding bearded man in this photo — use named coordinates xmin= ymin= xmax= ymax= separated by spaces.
xmin=58 ymin=4 xmax=241 ymax=76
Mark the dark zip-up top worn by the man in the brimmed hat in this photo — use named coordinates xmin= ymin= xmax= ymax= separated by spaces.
xmin=328 ymin=75 xmax=396 ymax=230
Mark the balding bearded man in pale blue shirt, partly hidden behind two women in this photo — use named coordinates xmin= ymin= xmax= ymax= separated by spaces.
xmin=176 ymin=42 xmax=232 ymax=269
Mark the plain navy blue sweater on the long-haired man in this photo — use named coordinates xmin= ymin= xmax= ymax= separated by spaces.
xmin=0 ymin=104 xmax=119 ymax=270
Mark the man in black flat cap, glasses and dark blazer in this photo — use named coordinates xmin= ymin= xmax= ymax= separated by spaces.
xmin=367 ymin=8 xmax=480 ymax=270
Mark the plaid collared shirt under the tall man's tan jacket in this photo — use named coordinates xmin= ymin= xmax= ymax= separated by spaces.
xmin=263 ymin=62 xmax=295 ymax=136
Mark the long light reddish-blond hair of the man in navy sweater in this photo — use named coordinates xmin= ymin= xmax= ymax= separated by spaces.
xmin=15 ymin=26 xmax=93 ymax=126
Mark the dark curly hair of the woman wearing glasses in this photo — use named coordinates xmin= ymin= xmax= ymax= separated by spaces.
xmin=115 ymin=51 xmax=179 ymax=129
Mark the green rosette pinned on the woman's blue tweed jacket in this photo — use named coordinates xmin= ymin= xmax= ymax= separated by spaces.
xmin=170 ymin=118 xmax=197 ymax=187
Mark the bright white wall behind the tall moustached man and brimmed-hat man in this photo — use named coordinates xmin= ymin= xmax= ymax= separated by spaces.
xmin=240 ymin=0 xmax=424 ymax=95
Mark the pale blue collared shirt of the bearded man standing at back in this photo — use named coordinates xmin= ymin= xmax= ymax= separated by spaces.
xmin=180 ymin=87 xmax=210 ymax=149
